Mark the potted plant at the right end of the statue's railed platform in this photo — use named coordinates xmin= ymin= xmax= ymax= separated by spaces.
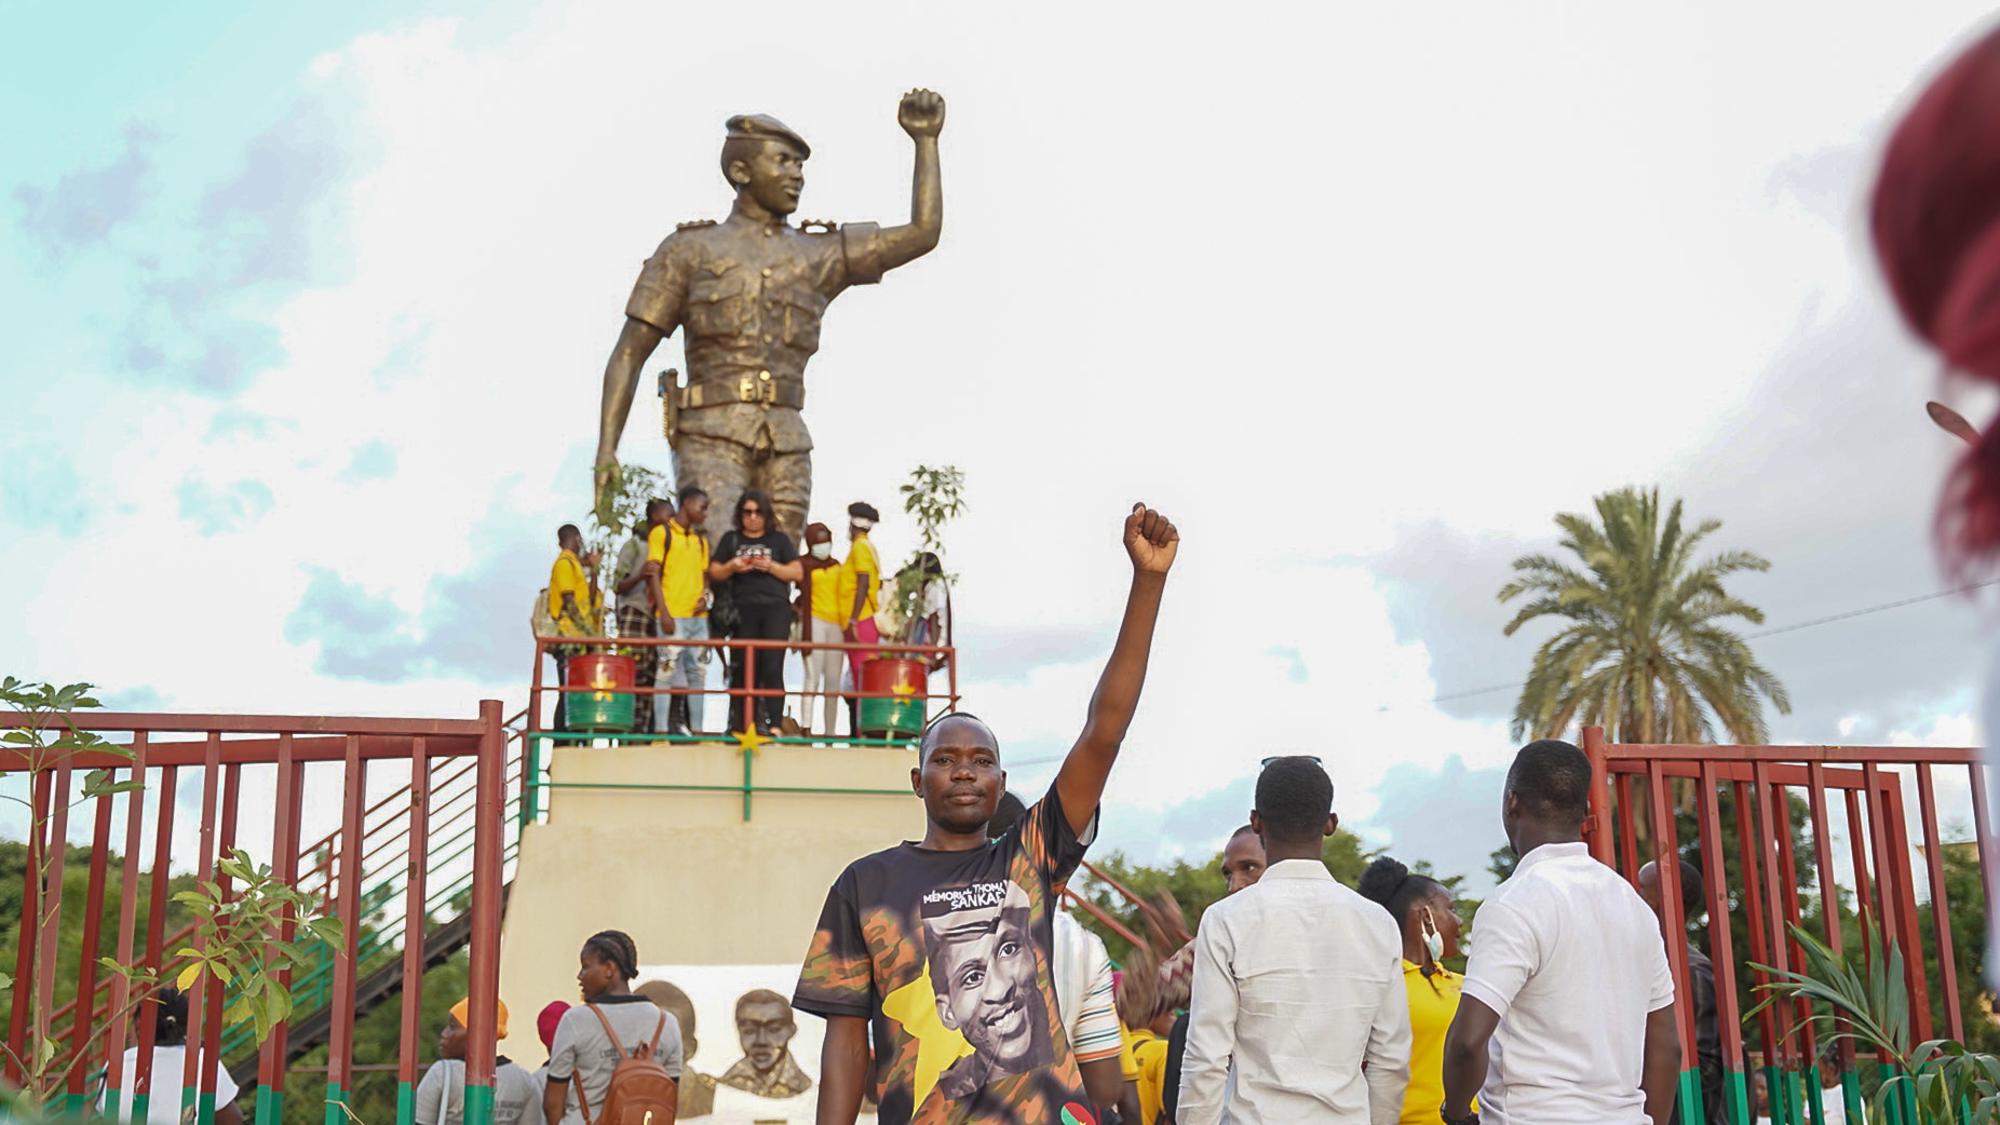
xmin=860 ymin=464 xmax=966 ymax=739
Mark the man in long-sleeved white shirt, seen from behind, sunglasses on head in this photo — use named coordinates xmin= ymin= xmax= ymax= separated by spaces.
xmin=1180 ymin=757 xmax=1410 ymax=1125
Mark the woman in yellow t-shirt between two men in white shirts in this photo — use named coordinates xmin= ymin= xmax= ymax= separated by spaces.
xmin=1356 ymin=855 xmax=1464 ymax=1125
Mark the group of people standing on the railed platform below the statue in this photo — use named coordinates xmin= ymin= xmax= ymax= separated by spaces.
xmin=536 ymin=486 xmax=952 ymax=739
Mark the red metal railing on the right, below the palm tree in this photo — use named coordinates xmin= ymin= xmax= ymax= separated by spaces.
xmin=1584 ymin=727 xmax=1996 ymax=1125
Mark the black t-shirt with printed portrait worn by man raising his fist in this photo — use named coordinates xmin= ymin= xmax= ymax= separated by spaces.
xmin=792 ymin=789 xmax=1096 ymax=1125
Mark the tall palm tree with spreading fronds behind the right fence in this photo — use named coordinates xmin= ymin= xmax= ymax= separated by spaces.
xmin=1500 ymin=488 xmax=1792 ymax=745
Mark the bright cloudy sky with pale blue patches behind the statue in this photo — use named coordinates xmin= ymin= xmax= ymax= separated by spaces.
xmin=0 ymin=2 xmax=1988 ymax=884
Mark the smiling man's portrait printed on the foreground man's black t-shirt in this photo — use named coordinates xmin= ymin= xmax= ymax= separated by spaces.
xmin=922 ymin=881 xmax=1056 ymax=1101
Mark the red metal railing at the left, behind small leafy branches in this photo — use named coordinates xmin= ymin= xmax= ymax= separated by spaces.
xmin=0 ymin=701 xmax=504 ymax=1121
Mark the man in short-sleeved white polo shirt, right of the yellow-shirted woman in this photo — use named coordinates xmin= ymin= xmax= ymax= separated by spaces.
xmin=1448 ymin=739 xmax=1680 ymax=1125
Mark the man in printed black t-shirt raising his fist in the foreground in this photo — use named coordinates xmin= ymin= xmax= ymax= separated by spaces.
xmin=792 ymin=504 xmax=1180 ymax=1125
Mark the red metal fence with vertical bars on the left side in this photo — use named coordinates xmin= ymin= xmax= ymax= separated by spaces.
xmin=0 ymin=701 xmax=522 ymax=1123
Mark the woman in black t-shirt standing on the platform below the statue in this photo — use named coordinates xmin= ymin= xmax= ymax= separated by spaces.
xmin=708 ymin=488 xmax=804 ymax=735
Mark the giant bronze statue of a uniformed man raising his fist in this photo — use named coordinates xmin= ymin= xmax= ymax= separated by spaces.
xmin=594 ymin=90 xmax=944 ymax=542
